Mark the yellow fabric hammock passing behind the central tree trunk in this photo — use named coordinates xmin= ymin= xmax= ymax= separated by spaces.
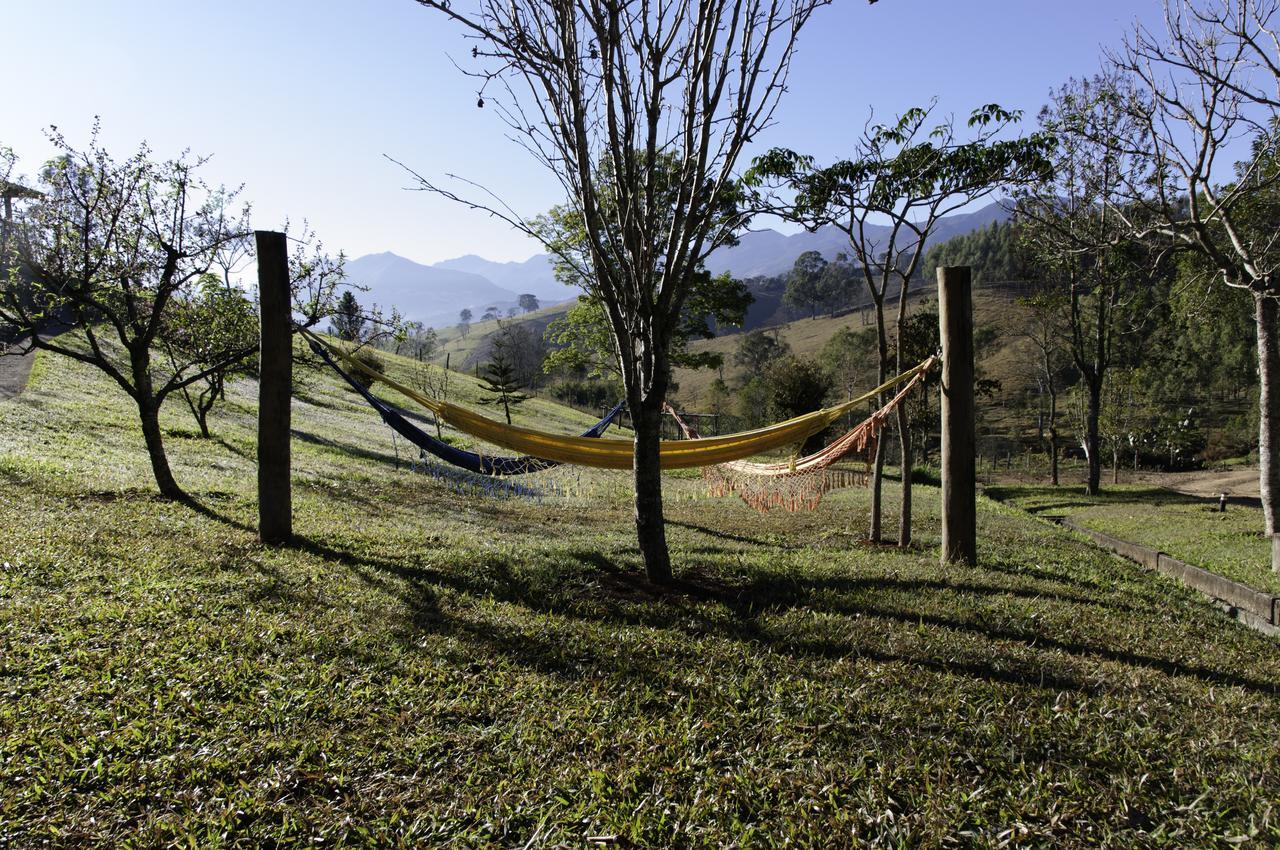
xmin=302 ymin=329 xmax=934 ymax=470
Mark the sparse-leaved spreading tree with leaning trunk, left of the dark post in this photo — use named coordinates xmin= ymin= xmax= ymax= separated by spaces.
xmin=0 ymin=127 xmax=256 ymax=499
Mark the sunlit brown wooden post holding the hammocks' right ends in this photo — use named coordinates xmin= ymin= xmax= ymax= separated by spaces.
xmin=938 ymin=266 xmax=978 ymax=565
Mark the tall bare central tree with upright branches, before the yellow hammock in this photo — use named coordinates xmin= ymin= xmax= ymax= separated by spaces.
xmin=419 ymin=0 xmax=829 ymax=582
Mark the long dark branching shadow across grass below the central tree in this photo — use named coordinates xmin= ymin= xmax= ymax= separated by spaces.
xmin=282 ymin=527 xmax=1277 ymax=694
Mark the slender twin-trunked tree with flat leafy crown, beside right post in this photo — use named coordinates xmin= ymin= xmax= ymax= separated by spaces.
xmin=751 ymin=104 xmax=1051 ymax=547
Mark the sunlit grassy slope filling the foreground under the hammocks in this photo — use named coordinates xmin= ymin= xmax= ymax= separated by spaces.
xmin=0 ymin=348 xmax=1280 ymax=847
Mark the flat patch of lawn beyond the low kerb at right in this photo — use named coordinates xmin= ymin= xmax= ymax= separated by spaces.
xmin=987 ymin=484 xmax=1280 ymax=593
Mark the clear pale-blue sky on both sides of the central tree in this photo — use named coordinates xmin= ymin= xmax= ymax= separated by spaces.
xmin=0 ymin=0 xmax=1160 ymax=262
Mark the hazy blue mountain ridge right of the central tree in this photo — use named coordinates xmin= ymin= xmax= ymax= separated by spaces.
xmin=707 ymin=204 xmax=1009 ymax=278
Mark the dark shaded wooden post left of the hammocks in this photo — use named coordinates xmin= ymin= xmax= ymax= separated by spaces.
xmin=253 ymin=230 xmax=293 ymax=543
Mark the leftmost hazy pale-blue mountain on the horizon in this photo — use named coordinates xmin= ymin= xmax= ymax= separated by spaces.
xmin=347 ymin=251 xmax=518 ymax=328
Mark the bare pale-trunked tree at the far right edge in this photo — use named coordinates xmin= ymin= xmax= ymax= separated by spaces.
xmin=1110 ymin=0 xmax=1280 ymax=537
